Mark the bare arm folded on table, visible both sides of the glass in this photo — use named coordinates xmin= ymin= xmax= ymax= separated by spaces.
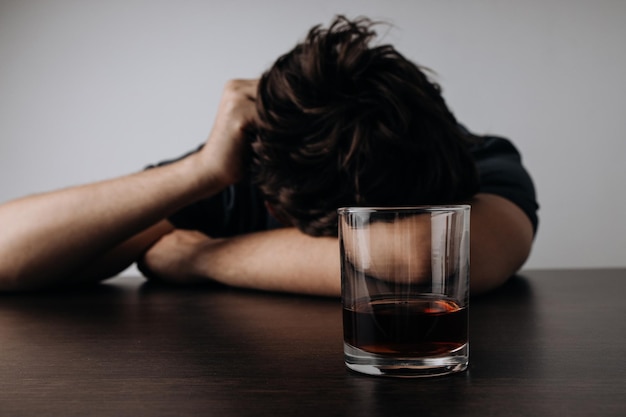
xmin=142 ymin=194 xmax=533 ymax=296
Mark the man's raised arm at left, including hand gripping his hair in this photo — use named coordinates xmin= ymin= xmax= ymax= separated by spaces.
xmin=0 ymin=81 xmax=257 ymax=290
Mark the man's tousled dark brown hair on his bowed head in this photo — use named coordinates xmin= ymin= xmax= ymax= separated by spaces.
xmin=253 ymin=16 xmax=478 ymax=236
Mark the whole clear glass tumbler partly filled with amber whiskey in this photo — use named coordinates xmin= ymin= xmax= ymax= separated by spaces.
xmin=339 ymin=205 xmax=470 ymax=378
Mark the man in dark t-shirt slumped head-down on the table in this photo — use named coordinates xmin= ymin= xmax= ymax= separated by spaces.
xmin=0 ymin=17 xmax=537 ymax=295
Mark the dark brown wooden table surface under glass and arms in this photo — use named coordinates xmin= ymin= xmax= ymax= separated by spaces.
xmin=0 ymin=269 xmax=626 ymax=417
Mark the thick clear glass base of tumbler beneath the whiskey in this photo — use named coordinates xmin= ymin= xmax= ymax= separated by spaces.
xmin=343 ymin=343 xmax=469 ymax=378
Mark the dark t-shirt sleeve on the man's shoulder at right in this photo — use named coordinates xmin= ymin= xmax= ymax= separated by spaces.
xmin=472 ymin=136 xmax=539 ymax=232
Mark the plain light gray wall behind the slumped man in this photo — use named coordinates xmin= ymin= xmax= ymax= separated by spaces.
xmin=0 ymin=0 xmax=626 ymax=268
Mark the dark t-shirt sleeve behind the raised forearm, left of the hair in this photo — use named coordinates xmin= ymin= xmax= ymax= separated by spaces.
xmin=147 ymin=147 xmax=267 ymax=237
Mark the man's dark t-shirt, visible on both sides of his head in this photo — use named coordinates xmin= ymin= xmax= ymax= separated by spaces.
xmin=150 ymin=136 xmax=539 ymax=237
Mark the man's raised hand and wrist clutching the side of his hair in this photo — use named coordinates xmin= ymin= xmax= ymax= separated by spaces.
xmin=199 ymin=80 xmax=258 ymax=193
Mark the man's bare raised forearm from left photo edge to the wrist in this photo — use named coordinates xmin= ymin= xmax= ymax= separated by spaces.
xmin=0 ymin=153 xmax=217 ymax=290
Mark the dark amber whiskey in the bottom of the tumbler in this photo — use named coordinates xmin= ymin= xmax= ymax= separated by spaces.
xmin=343 ymin=297 xmax=468 ymax=357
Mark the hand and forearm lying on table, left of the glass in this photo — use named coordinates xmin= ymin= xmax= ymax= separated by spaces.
xmin=138 ymin=228 xmax=341 ymax=296
